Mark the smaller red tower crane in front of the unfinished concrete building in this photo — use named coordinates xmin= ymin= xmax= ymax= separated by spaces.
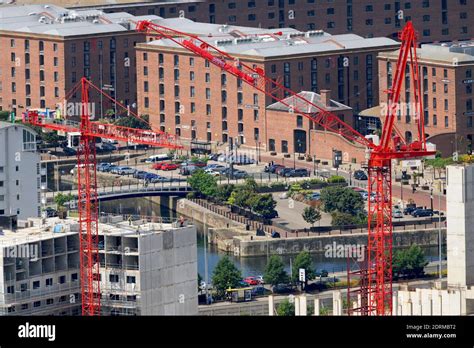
xmin=24 ymin=78 xmax=181 ymax=316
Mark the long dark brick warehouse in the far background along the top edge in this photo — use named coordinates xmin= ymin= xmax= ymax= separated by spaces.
xmin=78 ymin=0 xmax=474 ymax=42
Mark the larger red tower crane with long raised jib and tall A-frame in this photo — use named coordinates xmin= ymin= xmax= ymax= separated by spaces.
xmin=136 ymin=21 xmax=434 ymax=315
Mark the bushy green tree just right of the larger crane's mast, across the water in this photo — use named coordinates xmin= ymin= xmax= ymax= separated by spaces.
xmin=392 ymin=245 xmax=428 ymax=278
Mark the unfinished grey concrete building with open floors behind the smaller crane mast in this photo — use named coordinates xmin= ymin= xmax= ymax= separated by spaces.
xmin=0 ymin=216 xmax=198 ymax=315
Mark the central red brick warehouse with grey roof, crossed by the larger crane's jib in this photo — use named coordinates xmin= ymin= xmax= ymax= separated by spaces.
xmin=137 ymin=19 xmax=399 ymax=150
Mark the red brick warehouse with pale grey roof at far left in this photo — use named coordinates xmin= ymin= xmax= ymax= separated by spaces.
xmin=0 ymin=5 xmax=158 ymax=117
